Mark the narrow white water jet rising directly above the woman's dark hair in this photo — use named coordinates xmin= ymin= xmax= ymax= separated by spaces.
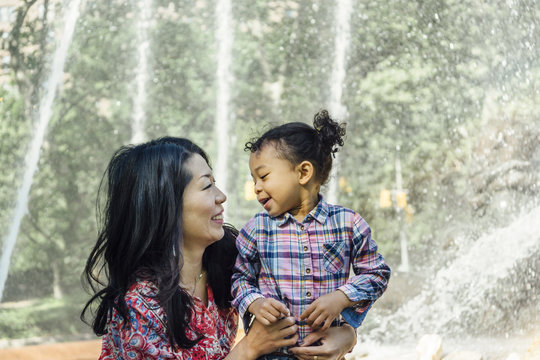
xmin=131 ymin=0 xmax=152 ymax=144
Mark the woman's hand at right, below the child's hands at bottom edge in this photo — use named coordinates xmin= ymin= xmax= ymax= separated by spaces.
xmin=290 ymin=324 xmax=356 ymax=360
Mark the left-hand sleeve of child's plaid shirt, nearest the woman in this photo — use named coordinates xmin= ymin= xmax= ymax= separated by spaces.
xmin=231 ymin=217 xmax=264 ymax=320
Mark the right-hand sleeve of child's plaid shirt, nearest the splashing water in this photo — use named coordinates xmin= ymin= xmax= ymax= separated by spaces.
xmin=339 ymin=214 xmax=390 ymax=327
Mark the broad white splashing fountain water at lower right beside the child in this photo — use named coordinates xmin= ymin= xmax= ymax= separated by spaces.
xmin=349 ymin=201 xmax=540 ymax=360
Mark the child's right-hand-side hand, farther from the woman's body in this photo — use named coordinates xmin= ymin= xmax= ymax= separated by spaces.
xmin=300 ymin=290 xmax=351 ymax=330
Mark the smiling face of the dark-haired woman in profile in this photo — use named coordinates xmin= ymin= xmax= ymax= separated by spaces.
xmin=182 ymin=154 xmax=227 ymax=248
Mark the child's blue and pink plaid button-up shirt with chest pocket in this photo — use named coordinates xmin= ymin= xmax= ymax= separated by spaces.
xmin=232 ymin=196 xmax=390 ymax=346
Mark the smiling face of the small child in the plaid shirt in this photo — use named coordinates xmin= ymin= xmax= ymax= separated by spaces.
xmin=249 ymin=143 xmax=302 ymax=216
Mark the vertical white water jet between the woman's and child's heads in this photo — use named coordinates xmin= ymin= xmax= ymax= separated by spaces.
xmin=215 ymin=0 xmax=233 ymax=210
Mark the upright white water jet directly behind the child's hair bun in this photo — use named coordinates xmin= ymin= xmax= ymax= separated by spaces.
xmin=327 ymin=0 xmax=353 ymax=204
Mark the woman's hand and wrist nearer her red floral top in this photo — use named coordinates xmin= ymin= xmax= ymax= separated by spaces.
xmin=225 ymin=317 xmax=298 ymax=360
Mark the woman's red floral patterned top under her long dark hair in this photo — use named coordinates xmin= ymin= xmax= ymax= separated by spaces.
xmin=100 ymin=280 xmax=238 ymax=360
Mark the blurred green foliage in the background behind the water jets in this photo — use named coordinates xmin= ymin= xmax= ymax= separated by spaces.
xmin=0 ymin=0 xmax=540 ymax=337
